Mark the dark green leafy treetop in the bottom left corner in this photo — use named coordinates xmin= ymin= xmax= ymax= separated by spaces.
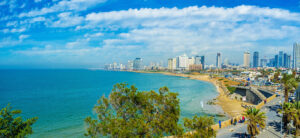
xmin=0 ymin=104 xmax=38 ymax=138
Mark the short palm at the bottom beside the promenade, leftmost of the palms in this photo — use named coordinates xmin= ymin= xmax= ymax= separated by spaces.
xmin=243 ymin=108 xmax=267 ymax=137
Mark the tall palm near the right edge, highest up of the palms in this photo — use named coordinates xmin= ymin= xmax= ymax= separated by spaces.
xmin=281 ymin=74 xmax=298 ymax=102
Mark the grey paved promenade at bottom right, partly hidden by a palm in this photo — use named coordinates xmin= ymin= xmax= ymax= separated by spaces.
xmin=217 ymin=96 xmax=283 ymax=138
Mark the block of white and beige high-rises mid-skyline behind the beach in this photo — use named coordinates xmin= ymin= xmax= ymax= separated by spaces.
xmin=168 ymin=54 xmax=205 ymax=71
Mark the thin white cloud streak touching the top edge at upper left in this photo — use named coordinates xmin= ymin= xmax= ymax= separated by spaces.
xmin=19 ymin=0 xmax=106 ymax=17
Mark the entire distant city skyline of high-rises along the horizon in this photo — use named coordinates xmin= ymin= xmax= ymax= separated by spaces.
xmin=105 ymin=43 xmax=300 ymax=71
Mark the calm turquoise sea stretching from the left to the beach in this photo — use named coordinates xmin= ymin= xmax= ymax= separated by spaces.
xmin=0 ymin=70 xmax=224 ymax=137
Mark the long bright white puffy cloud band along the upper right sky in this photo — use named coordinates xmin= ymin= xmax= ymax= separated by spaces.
xmin=86 ymin=5 xmax=300 ymax=22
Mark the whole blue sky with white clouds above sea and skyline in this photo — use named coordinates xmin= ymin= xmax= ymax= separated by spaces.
xmin=0 ymin=0 xmax=300 ymax=68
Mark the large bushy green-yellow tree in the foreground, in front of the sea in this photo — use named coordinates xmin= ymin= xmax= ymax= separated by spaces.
xmin=85 ymin=83 xmax=183 ymax=137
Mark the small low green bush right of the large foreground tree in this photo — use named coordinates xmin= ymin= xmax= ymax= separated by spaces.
xmin=184 ymin=116 xmax=216 ymax=138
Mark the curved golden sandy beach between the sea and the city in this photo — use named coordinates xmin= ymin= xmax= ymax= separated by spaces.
xmin=135 ymin=71 xmax=245 ymax=117
